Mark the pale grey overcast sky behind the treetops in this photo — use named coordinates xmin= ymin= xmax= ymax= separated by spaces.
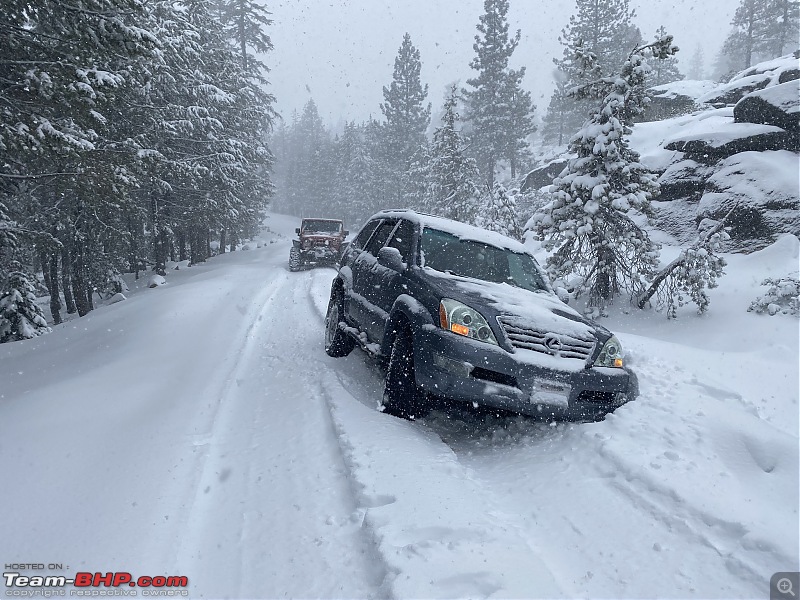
xmin=266 ymin=0 xmax=738 ymax=126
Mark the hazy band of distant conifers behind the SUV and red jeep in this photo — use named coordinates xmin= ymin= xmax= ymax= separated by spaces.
xmin=271 ymin=0 xmax=534 ymax=239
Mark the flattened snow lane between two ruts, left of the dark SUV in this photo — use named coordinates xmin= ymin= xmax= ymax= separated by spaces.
xmin=178 ymin=261 xmax=380 ymax=597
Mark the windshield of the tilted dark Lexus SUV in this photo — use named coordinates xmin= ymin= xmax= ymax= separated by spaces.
xmin=421 ymin=227 xmax=547 ymax=292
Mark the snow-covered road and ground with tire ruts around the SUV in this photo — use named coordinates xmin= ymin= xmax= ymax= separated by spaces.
xmin=0 ymin=216 xmax=798 ymax=598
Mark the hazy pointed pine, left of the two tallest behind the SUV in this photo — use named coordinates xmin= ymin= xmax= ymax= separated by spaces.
xmin=381 ymin=33 xmax=431 ymax=207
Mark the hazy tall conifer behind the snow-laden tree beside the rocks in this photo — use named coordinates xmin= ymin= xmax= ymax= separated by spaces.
xmin=542 ymin=0 xmax=642 ymax=145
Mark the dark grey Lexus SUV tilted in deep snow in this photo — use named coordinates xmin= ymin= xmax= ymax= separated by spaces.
xmin=325 ymin=210 xmax=638 ymax=420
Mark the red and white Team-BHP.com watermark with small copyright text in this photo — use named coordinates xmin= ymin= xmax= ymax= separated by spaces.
xmin=3 ymin=562 xmax=189 ymax=598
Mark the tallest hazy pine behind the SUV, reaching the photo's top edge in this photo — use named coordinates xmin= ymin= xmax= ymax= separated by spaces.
xmin=464 ymin=0 xmax=533 ymax=188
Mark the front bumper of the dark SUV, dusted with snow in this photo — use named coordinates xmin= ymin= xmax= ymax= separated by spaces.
xmin=414 ymin=326 xmax=639 ymax=421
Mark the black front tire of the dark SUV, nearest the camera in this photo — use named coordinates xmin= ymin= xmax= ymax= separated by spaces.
xmin=383 ymin=326 xmax=430 ymax=419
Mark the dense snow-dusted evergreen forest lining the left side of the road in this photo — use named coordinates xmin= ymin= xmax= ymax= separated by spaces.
xmin=0 ymin=0 xmax=274 ymax=341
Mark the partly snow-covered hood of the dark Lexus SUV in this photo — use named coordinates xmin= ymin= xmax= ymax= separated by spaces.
xmin=426 ymin=269 xmax=611 ymax=342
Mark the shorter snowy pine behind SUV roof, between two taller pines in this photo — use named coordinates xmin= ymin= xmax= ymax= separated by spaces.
xmin=425 ymin=84 xmax=480 ymax=223
